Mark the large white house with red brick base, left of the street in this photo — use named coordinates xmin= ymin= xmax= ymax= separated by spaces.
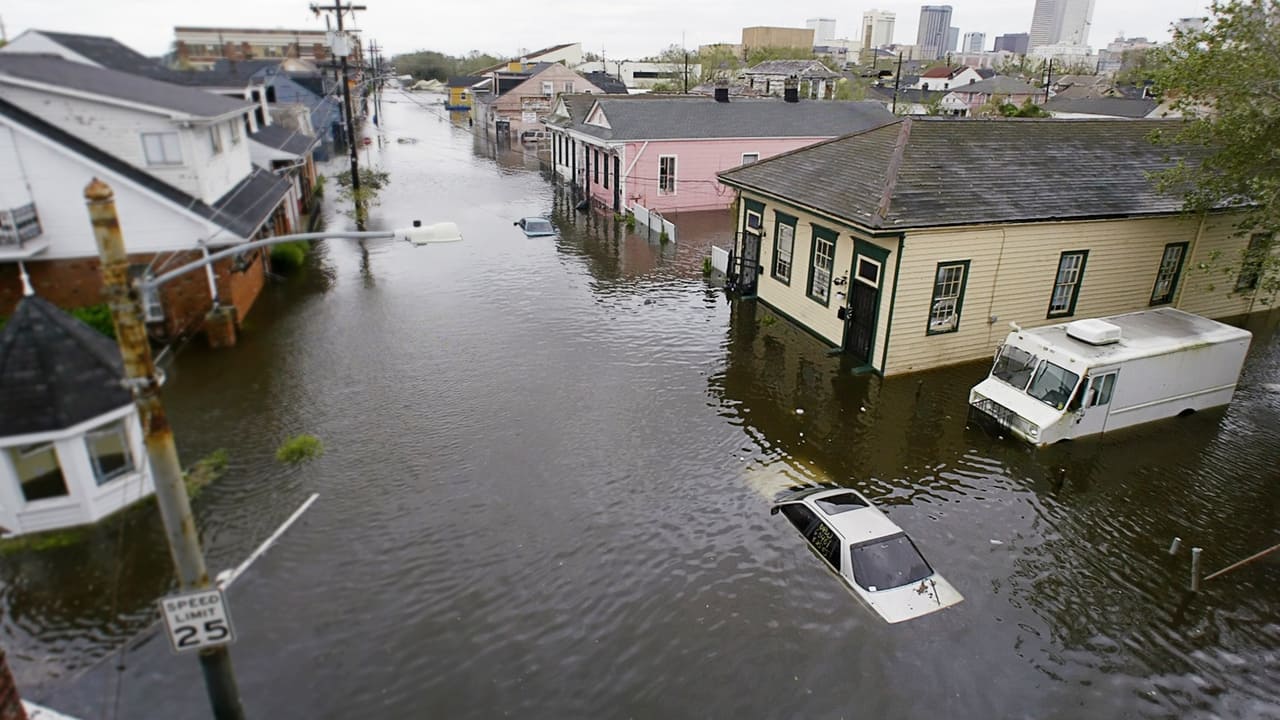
xmin=0 ymin=53 xmax=291 ymax=342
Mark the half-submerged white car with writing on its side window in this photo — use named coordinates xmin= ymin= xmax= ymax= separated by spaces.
xmin=769 ymin=488 xmax=964 ymax=623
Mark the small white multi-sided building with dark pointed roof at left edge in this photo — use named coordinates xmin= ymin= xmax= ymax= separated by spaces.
xmin=0 ymin=296 xmax=155 ymax=536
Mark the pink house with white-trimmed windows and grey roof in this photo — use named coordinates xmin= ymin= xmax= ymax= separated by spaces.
xmin=547 ymin=88 xmax=895 ymax=214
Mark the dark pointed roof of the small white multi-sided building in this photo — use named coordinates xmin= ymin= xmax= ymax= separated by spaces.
xmin=0 ymin=296 xmax=133 ymax=436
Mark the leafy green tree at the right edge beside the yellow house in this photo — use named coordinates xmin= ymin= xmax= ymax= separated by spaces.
xmin=1152 ymin=0 xmax=1280 ymax=302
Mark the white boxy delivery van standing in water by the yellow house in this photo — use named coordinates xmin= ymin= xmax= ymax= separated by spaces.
xmin=969 ymin=307 xmax=1253 ymax=445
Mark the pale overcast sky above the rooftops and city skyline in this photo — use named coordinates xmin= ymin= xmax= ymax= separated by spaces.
xmin=0 ymin=0 xmax=1208 ymax=58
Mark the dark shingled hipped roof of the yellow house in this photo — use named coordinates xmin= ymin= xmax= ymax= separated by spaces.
xmin=719 ymin=118 xmax=1185 ymax=231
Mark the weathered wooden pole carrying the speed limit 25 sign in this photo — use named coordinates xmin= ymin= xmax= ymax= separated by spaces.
xmin=84 ymin=179 xmax=244 ymax=720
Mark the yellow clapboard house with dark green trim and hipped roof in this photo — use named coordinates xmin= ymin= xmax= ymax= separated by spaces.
xmin=719 ymin=118 xmax=1271 ymax=375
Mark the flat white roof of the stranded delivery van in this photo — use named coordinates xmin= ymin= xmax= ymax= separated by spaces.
xmin=1011 ymin=307 xmax=1253 ymax=366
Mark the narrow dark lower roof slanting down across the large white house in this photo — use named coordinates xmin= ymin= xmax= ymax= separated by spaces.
xmin=0 ymin=95 xmax=289 ymax=245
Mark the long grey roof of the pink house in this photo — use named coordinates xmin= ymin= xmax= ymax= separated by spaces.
xmin=548 ymin=95 xmax=893 ymax=140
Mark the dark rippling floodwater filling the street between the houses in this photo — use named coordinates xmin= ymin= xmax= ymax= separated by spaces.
xmin=0 ymin=92 xmax=1280 ymax=719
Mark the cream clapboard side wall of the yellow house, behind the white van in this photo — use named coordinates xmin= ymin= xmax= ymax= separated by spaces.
xmin=884 ymin=217 xmax=1244 ymax=374
